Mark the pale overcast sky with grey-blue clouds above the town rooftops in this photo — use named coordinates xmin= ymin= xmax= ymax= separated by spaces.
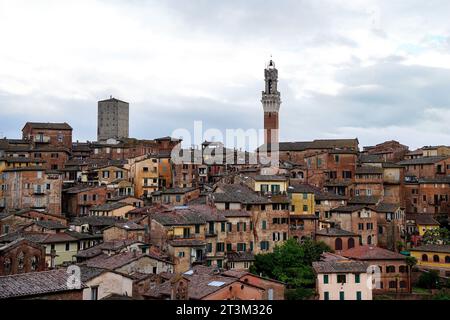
xmin=0 ymin=0 xmax=450 ymax=149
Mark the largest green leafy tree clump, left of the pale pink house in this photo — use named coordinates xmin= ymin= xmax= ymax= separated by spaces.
xmin=250 ymin=239 xmax=331 ymax=300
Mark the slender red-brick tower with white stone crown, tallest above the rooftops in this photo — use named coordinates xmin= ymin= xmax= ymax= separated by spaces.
xmin=261 ymin=60 xmax=281 ymax=145
